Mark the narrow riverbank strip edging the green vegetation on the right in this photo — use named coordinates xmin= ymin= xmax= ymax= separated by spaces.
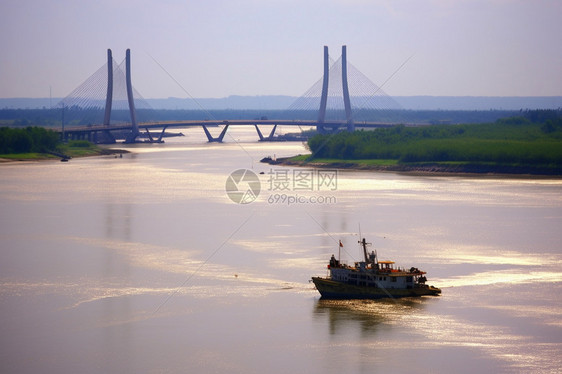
xmin=261 ymin=155 xmax=562 ymax=177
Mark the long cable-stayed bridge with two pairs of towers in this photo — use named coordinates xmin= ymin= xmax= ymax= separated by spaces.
xmin=58 ymin=46 xmax=400 ymax=143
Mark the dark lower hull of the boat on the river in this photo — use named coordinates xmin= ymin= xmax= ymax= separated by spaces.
xmin=312 ymin=277 xmax=441 ymax=299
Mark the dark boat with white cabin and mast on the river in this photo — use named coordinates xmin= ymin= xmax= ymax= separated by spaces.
xmin=312 ymin=238 xmax=441 ymax=299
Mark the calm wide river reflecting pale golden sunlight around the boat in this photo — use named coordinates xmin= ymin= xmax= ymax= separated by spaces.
xmin=0 ymin=129 xmax=562 ymax=374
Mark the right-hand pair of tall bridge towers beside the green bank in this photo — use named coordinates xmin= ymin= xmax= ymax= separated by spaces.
xmin=317 ymin=45 xmax=355 ymax=131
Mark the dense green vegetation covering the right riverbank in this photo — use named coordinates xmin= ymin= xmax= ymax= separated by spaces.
xmin=308 ymin=111 xmax=562 ymax=170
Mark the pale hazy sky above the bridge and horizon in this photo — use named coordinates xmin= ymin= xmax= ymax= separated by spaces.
xmin=0 ymin=0 xmax=562 ymax=98
